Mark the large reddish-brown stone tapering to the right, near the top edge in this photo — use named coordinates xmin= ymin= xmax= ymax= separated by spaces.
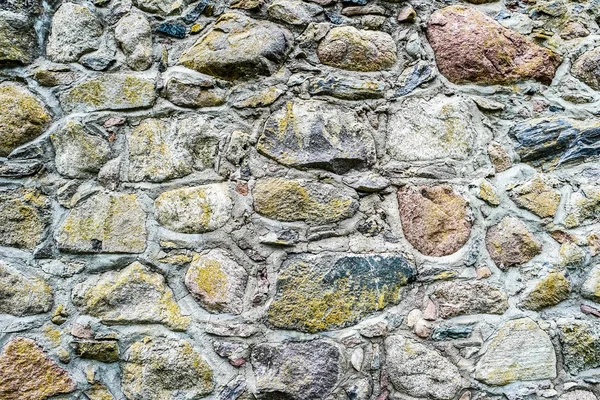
xmin=427 ymin=5 xmax=561 ymax=84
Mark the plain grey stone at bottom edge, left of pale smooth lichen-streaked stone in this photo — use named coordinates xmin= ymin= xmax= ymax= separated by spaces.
xmin=385 ymin=335 xmax=464 ymax=400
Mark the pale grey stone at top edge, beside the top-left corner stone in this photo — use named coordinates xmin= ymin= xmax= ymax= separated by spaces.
xmin=46 ymin=3 xmax=103 ymax=63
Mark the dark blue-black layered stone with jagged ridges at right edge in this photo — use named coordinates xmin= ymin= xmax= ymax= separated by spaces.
xmin=508 ymin=117 xmax=600 ymax=168
